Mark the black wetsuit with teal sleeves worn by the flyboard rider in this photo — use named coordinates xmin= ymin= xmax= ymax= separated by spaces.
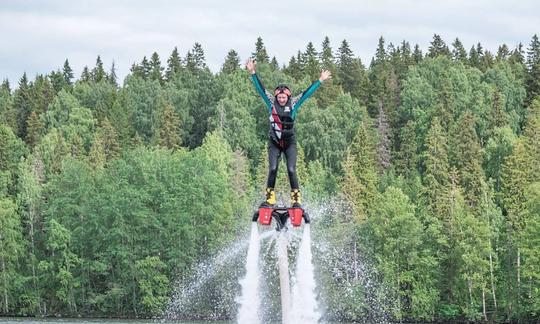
xmin=251 ymin=73 xmax=321 ymax=189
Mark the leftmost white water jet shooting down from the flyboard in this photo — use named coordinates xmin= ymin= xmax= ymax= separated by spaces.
xmin=237 ymin=222 xmax=260 ymax=324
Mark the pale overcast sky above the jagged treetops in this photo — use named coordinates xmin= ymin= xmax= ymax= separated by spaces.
xmin=0 ymin=0 xmax=540 ymax=86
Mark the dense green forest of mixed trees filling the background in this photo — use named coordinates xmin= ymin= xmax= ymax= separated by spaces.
xmin=0 ymin=34 xmax=540 ymax=322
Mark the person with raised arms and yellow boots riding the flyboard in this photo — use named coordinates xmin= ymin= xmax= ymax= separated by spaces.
xmin=246 ymin=58 xmax=332 ymax=208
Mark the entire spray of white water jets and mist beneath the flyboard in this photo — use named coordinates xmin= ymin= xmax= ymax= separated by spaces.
xmin=164 ymin=199 xmax=394 ymax=323
